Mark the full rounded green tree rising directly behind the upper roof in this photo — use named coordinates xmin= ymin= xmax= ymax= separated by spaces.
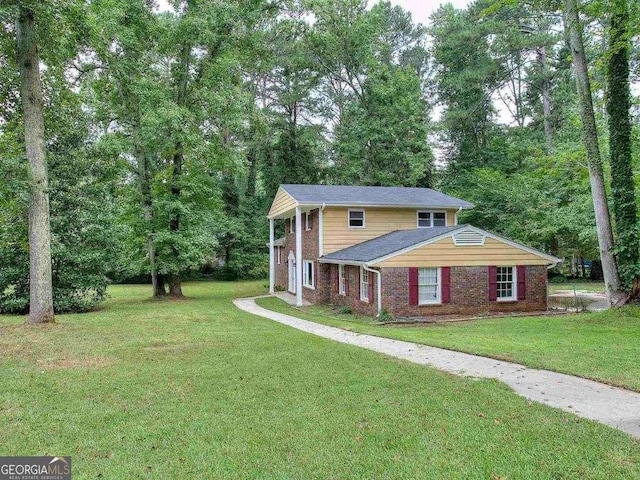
xmin=334 ymin=65 xmax=433 ymax=186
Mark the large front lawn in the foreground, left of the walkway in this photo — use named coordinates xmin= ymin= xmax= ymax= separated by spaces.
xmin=0 ymin=282 xmax=640 ymax=479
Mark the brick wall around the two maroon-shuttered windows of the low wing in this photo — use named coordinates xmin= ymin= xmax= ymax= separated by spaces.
xmin=382 ymin=265 xmax=547 ymax=317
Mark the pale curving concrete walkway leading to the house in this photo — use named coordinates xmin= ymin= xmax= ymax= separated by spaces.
xmin=233 ymin=298 xmax=640 ymax=438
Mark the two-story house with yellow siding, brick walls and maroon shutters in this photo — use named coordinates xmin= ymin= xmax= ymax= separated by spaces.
xmin=268 ymin=185 xmax=560 ymax=316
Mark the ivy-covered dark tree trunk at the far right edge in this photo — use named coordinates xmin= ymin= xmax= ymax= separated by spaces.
xmin=607 ymin=0 xmax=640 ymax=297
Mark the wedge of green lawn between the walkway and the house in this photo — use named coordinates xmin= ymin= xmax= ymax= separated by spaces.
xmin=258 ymin=298 xmax=640 ymax=391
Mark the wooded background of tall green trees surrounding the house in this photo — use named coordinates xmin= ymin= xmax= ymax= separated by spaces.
xmin=0 ymin=0 xmax=640 ymax=313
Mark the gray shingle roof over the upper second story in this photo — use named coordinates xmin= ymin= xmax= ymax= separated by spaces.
xmin=281 ymin=184 xmax=473 ymax=208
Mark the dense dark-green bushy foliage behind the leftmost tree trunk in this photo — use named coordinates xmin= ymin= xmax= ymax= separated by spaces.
xmin=0 ymin=102 xmax=117 ymax=313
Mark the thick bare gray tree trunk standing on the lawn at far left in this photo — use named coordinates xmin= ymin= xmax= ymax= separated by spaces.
xmin=16 ymin=7 xmax=54 ymax=323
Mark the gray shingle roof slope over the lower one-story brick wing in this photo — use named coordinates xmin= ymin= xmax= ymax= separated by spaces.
xmin=322 ymin=225 xmax=466 ymax=263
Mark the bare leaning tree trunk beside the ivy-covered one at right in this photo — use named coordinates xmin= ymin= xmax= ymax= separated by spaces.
xmin=564 ymin=0 xmax=627 ymax=306
